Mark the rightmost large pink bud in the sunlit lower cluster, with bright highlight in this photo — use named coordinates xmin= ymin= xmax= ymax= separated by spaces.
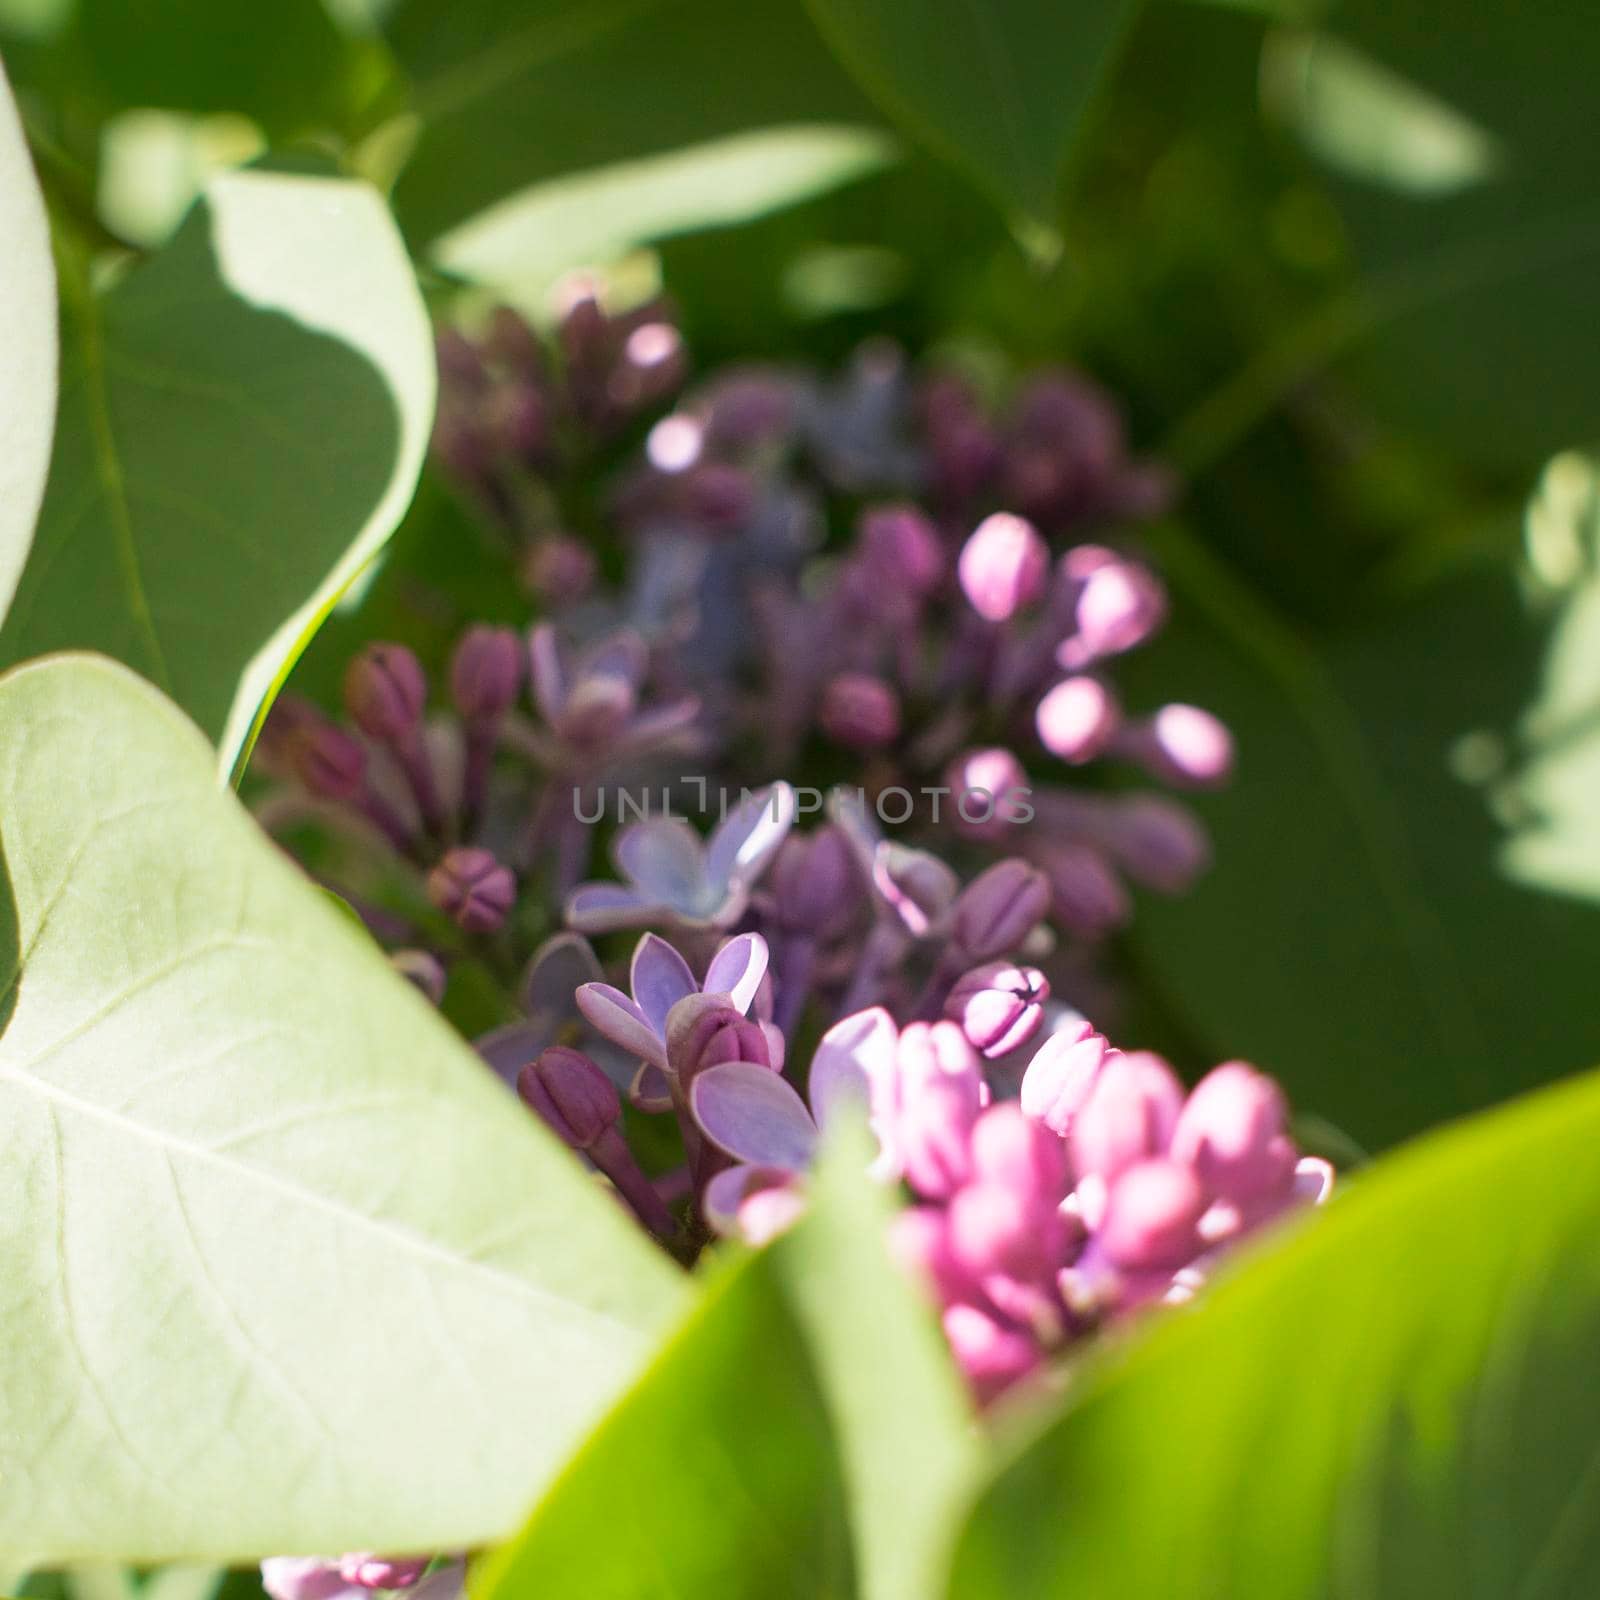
xmin=1171 ymin=1061 xmax=1296 ymax=1206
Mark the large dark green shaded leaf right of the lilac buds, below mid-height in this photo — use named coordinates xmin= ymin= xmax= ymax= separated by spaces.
xmin=1123 ymin=530 xmax=1600 ymax=1149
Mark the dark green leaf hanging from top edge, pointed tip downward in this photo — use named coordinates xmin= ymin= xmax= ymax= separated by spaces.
xmin=808 ymin=0 xmax=1134 ymax=237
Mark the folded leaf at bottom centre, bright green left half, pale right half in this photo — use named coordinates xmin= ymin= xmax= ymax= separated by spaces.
xmin=475 ymin=1130 xmax=978 ymax=1600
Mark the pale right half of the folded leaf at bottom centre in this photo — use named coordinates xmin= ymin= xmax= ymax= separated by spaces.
xmin=773 ymin=1126 xmax=979 ymax=1600
